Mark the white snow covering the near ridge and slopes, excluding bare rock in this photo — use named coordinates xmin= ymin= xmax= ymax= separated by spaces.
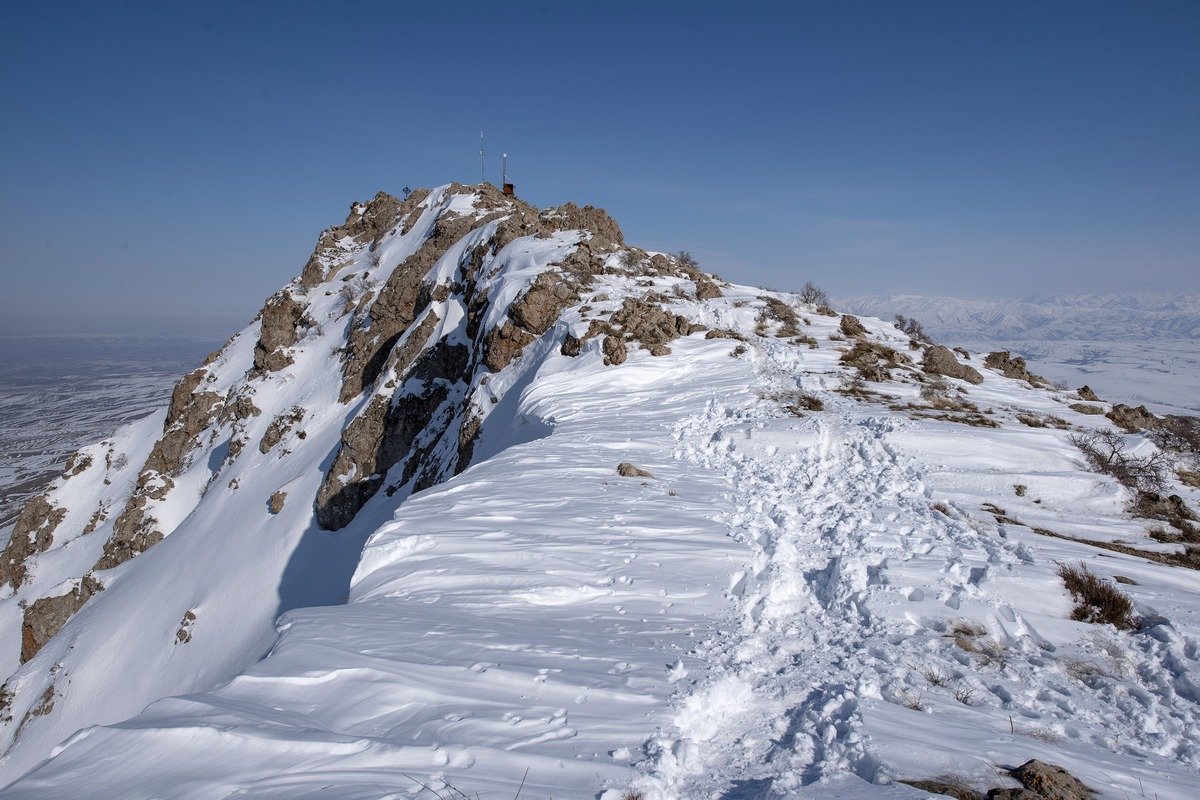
xmin=0 ymin=191 xmax=1200 ymax=800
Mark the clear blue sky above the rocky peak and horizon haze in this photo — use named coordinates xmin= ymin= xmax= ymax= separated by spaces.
xmin=0 ymin=0 xmax=1200 ymax=335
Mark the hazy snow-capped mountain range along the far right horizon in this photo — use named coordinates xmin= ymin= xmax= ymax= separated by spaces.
xmin=835 ymin=294 xmax=1200 ymax=341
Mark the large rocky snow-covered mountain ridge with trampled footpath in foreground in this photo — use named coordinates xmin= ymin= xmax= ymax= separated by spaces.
xmin=0 ymin=185 xmax=1200 ymax=800
